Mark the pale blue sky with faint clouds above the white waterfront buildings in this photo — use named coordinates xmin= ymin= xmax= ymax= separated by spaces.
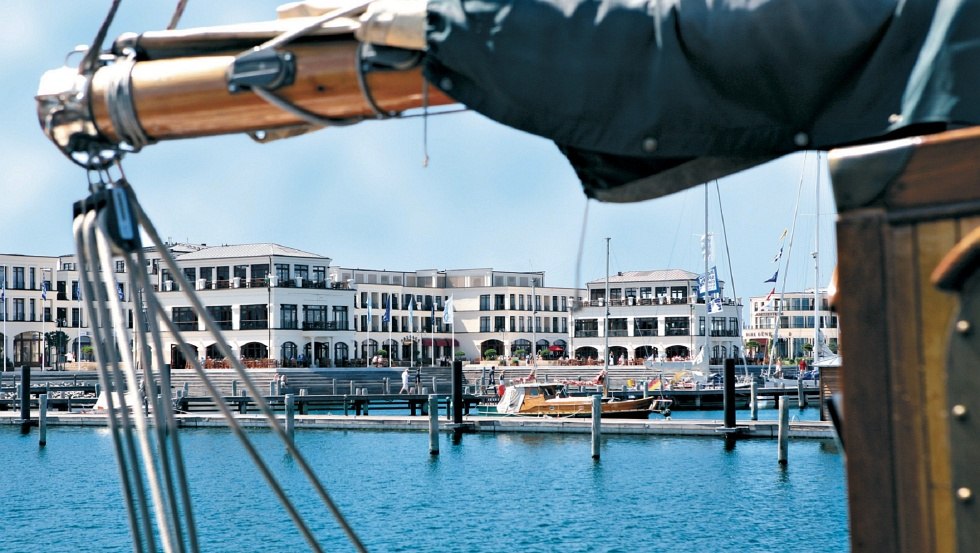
xmin=0 ymin=0 xmax=836 ymax=299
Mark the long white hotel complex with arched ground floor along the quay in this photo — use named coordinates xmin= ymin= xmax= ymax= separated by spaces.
xmin=0 ymin=244 xmax=741 ymax=368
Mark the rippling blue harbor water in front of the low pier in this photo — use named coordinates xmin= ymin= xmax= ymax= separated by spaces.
xmin=0 ymin=412 xmax=849 ymax=552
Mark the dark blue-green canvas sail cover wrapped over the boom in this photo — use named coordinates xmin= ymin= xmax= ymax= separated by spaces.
xmin=425 ymin=0 xmax=980 ymax=201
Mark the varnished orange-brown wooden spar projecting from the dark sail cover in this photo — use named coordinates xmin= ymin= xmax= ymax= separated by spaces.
xmin=91 ymin=38 xmax=453 ymax=142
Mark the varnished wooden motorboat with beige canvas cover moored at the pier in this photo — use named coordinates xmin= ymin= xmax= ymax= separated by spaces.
xmin=497 ymin=382 xmax=655 ymax=419
